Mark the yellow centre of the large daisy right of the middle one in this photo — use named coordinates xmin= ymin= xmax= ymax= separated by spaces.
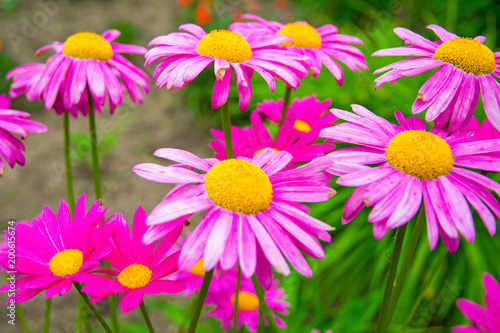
xmin=386 ymin=130 xmax=453 ymax=180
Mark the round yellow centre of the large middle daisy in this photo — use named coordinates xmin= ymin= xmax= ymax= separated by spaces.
xmin=205 ymin=159 xmax=273 ymax=214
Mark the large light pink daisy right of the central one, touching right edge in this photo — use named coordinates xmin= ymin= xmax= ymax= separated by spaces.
xmin=320 ymin=105 xmax=500 ymax=252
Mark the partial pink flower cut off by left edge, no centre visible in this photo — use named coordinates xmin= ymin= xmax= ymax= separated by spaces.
xmin=0 ymin=94 xmax=47 ymax=176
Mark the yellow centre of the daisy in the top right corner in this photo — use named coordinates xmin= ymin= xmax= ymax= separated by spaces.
xmin=433 ymin=38 xmax=495 ymax=75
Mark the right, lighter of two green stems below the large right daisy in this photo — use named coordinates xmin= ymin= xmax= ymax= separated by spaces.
xmin=385 ymin=206 xmax=425 ymax=330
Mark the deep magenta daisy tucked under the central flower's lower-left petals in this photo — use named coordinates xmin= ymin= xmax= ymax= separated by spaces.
xmin=80 ymin=206 xmax=186 ymax=313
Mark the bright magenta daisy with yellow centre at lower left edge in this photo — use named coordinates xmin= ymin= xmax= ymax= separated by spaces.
xmin=0 ymin=194 xmax=116 ymax=304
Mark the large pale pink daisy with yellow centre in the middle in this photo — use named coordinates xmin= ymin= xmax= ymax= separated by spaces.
xmin=134 ymin=148 xmax=334 ymax=287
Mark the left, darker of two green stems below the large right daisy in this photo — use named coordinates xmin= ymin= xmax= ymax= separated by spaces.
xmin=376 ymin=224 xmax=407 ymax=333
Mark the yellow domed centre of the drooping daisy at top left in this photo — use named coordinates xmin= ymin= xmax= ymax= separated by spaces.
xmin=63 ymin=32 xmax=113 ymax=61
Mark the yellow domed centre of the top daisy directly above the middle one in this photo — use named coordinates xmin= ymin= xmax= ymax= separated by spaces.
xmin=196 ymin=30 xmax=252 ymax=62
